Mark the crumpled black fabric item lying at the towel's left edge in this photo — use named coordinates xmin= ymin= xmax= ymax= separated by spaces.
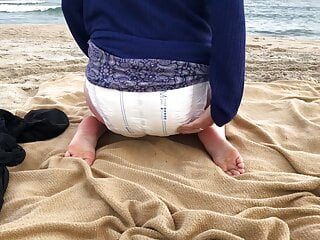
xmin=0 ymin=109 xmax=69 ymax=210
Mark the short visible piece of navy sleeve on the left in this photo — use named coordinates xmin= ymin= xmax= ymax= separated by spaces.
xmin=62 ymin=0 xmax=90 ymax=56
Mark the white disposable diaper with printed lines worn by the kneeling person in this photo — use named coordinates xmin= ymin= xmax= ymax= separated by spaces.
xmin=86 ymin=80 xmax=210 ymax=137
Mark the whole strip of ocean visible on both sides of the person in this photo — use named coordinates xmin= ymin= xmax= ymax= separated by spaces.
xmin=0 ymin=0 xmax=320 ymax=39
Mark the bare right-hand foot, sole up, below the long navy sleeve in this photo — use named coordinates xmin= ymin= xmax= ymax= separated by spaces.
xmin=198 ymin=126 xmax=244 ymax=176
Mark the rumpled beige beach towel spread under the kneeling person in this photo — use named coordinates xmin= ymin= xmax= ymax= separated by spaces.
xmin=0 ymin=75 xmax=320 ymax=240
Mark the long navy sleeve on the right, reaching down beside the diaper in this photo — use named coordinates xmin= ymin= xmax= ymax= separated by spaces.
xmin=207 ymin=0 xmax=246 ymax=126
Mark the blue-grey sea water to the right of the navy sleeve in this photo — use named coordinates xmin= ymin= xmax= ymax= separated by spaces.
xmin=245 ymin=0 xmax=320 ymax=39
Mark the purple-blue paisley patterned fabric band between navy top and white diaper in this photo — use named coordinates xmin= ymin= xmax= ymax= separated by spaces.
xmin=86 ymin=41 xmax=208 ymax=92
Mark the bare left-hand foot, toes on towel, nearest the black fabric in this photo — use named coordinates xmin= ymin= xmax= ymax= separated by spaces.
xmin=64 ymin=116 xmax=107 ymax=165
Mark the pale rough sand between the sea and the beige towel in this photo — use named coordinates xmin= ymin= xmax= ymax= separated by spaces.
xmin=0 ymin=25 xmax=320 ymax=111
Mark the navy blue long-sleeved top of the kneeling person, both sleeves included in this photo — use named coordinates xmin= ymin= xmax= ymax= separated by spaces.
xmin=62 ymin=0 xmax=246 ymax=126
